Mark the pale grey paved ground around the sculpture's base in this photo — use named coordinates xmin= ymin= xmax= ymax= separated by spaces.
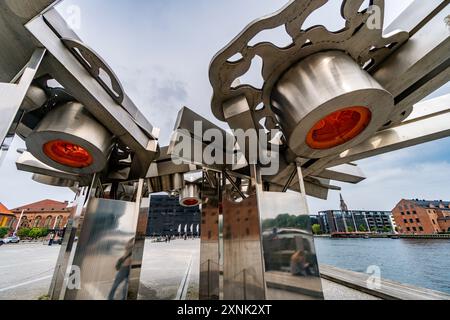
xmin=0 ymin=240 xmax=375 ymax=300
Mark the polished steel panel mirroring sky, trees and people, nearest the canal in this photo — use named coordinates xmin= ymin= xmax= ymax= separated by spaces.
xmin=252 ymin=166 xmax=324 ymax=300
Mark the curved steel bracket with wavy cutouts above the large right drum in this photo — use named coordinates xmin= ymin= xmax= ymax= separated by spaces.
xmin=209 ymin=0 xmax=409 ymax=129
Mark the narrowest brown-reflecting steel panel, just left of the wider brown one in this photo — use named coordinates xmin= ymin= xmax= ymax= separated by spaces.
xmin=199 ymin=172 xmax=220 ymax=300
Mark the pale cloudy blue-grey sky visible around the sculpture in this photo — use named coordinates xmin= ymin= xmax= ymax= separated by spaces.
xmin=0 ymin=0 xmax=450 ymax=213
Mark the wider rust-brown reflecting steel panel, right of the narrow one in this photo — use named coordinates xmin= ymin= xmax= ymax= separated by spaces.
xmin=222 ymin=182 xmax=266 ymax=300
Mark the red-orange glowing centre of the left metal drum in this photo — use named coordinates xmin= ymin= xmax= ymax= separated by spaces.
xmin=44 ymin=140 xmax=94 ymax=168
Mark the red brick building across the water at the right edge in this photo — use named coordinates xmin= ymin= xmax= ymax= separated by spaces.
xmin=392 ymin=199 xmax=450 ymax=234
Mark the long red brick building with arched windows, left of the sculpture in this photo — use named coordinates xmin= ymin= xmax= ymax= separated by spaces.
xmin=11 ymin=200 xmax=71 ymax=230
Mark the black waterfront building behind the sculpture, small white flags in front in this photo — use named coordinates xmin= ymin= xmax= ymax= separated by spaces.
xmin=147 ymin=195 xmax=200 ymax=236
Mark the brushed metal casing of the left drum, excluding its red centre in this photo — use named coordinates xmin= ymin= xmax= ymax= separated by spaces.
xmin=26 ymin=102 xmax=113 ymax=175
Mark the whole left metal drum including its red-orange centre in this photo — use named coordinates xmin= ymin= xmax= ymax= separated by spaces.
xmin=26 ymin=102 xmax=113 ymax=175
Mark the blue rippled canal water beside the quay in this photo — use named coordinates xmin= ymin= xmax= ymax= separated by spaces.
xmin=315 ymin=238 xmax=450 ymax=293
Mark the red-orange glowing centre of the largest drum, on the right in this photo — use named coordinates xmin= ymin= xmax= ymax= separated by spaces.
xmin=306 ymin=107 xmax=372 ymax=150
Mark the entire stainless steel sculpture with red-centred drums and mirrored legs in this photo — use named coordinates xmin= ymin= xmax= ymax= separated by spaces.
xmin=0 ymin=0 xmax=450 ymax=299
